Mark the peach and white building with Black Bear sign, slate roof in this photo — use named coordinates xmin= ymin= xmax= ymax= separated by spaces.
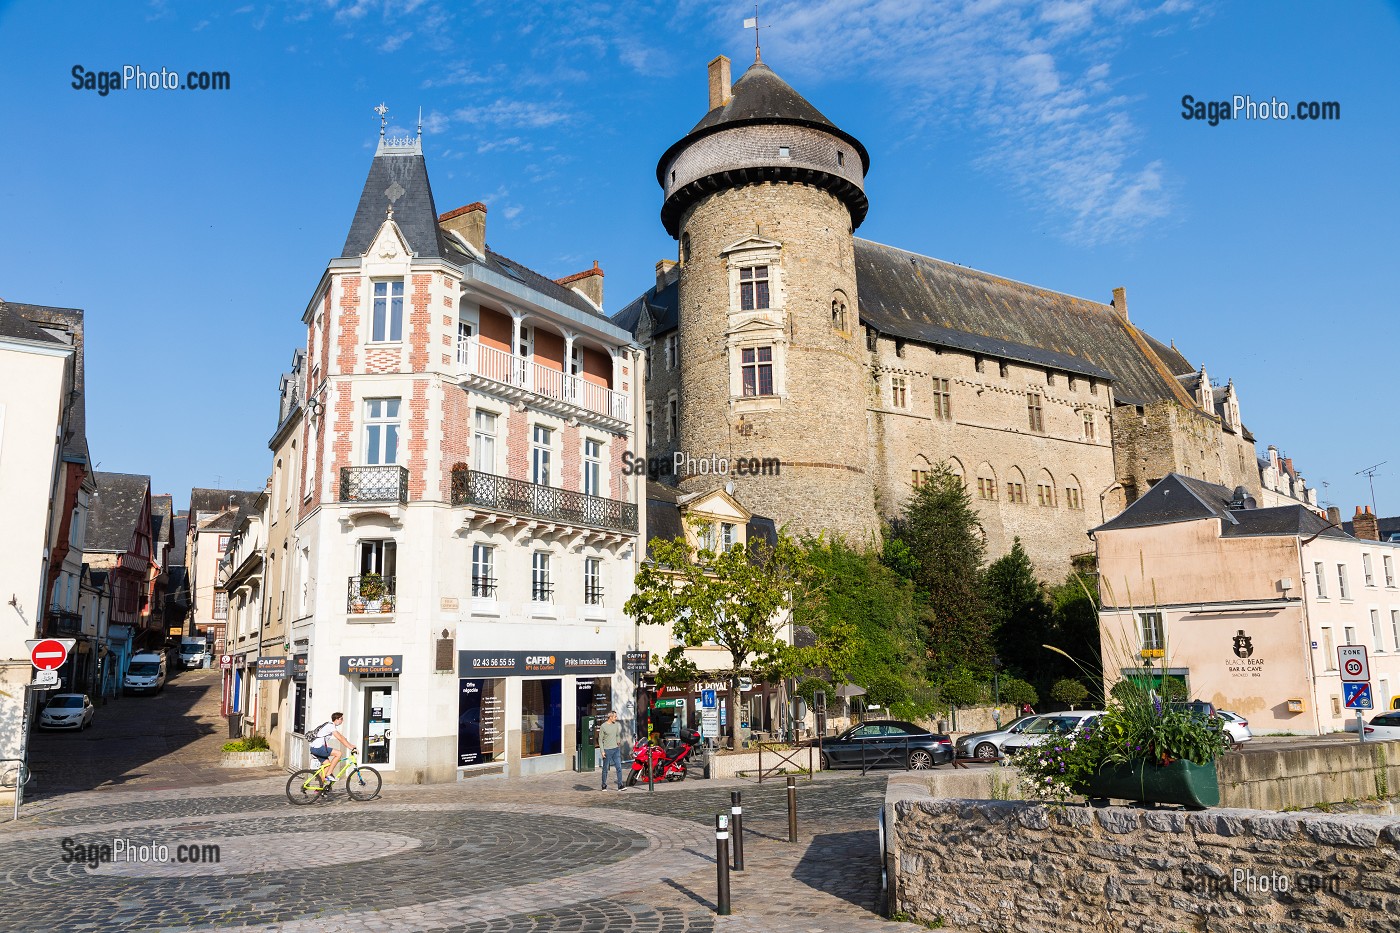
xmin=1093 ymin=474 xmax=1400 ymax=734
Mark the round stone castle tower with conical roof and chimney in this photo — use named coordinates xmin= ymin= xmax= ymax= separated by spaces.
xmin=652 ymin=56 xmax=879 ymax=537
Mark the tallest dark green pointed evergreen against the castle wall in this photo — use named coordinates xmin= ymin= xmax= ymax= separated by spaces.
xmin=882 ymin=462 xmax=993 ymax=684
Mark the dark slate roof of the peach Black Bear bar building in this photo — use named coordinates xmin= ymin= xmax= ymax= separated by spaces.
xmin=1089 ymin=474 xmax=1350 ymax=538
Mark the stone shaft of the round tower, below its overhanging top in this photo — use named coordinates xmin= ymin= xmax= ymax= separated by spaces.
xmin=674 ymin=182 xmax=878 ymax=545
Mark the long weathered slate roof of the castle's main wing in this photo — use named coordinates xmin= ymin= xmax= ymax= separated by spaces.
xmin=855 ymin=238 xmax=1184 ymax=405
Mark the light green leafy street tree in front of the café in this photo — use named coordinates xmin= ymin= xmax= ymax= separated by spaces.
xmin=623 ymin=523 xmax=850 ymax=748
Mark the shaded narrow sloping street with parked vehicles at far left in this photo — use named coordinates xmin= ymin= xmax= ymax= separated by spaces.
xmin=25 ymin=670 xmax=281 ymax=799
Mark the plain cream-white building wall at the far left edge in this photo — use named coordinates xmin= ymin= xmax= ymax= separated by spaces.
xmin=0 ymin=303 xmax=76 ymax=790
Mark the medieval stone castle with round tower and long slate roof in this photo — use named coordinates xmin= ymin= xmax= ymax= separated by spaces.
xmin=613 ymin=56 xmax=1260 ymax=579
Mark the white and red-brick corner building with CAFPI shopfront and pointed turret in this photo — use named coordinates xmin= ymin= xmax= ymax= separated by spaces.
xmin=298 ymin=123 xmax=644 ymax=783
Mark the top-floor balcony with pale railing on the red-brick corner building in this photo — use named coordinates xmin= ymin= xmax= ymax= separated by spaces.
xmin=456 ymin=338 xmax=631 ymax=426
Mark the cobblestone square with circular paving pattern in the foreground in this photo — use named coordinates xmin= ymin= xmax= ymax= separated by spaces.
xmin=0 ymin=750 xmax=952 ymax=933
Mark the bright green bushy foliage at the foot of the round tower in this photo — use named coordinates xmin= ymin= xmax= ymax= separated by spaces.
xmin=794 ymin=539 xmax=932 ymax=719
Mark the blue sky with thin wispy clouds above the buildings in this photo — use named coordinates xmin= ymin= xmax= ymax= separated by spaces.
xmin=0 ymin=0 xmax=1400 ymax=516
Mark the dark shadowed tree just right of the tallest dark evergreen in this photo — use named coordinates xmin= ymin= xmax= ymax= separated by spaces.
xmin=983 ymin=538 xmax=1057 ymax=683
